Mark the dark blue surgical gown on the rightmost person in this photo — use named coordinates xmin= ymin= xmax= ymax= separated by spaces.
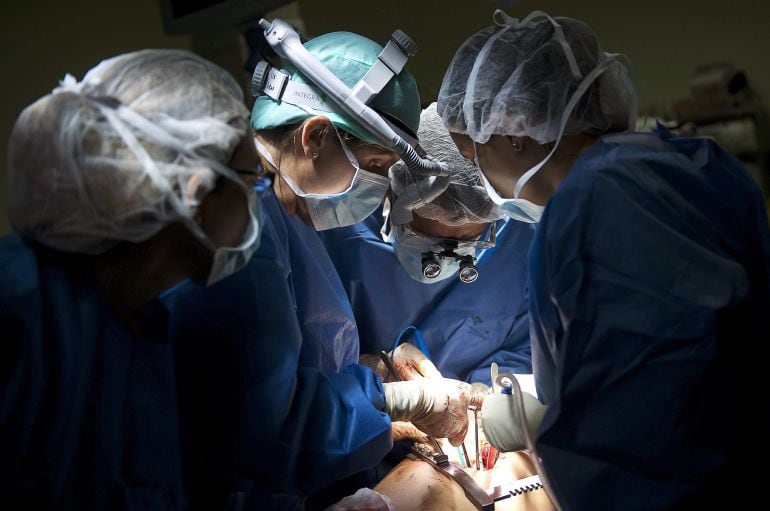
xmin=530 ymin=129 xmax=770 ymax=510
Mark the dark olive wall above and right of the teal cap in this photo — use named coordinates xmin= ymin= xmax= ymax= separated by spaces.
xmin=300 ymin=0 xmax=770 ymax=114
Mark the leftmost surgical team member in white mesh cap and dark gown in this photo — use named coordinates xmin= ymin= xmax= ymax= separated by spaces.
xmin=0 ymin=50 xmax=259 ymax=510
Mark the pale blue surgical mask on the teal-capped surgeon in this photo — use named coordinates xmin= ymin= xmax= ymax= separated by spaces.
xmin=254 ymin=134 xmax=390 ymax=231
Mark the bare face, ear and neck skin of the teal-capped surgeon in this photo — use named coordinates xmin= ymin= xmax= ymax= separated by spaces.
xmin=256 ymin=116 xmax=399 ymax=226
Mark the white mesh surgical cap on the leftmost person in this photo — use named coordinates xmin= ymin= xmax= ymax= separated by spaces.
xmin=8 ymin=50 xmax=249 ymax=254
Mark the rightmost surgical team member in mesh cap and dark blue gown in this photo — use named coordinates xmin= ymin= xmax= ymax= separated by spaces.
xmin=438 ymin=11 xmax=770 ymax=510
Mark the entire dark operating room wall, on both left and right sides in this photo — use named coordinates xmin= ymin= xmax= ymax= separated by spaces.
xmin=0 ymin=0 xmax=770 ymax=235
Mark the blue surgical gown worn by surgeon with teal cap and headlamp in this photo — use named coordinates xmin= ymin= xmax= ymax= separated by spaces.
xmin=167 ymin=182 xmax=392 ymax=509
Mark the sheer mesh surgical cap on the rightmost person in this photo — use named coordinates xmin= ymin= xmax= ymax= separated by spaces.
xmin=438 ymin=11 xmax=636 ymax=144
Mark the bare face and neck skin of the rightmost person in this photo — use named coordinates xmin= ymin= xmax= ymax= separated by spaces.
xmin=450 ymin=133 xmax=597 ymax=206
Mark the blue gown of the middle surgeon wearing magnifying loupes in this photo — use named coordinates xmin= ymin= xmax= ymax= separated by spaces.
xmin=321 ymin=211 xmax=533 ymax=384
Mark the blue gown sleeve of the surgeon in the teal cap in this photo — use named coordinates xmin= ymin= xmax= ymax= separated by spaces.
xmin=167 ymin=256 xmax=392 ymax=494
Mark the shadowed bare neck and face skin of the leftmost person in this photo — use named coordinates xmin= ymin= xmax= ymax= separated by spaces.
xmin=92 ymin=135 xmax=257 ymax=324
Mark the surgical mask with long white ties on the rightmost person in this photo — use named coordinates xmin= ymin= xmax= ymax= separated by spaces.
xmin=473 ymin=27 xmax=618 ymax=223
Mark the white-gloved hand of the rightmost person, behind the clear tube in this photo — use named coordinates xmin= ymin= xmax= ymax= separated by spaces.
xmin=481 ymin=392 xmax=548 ymax=452
